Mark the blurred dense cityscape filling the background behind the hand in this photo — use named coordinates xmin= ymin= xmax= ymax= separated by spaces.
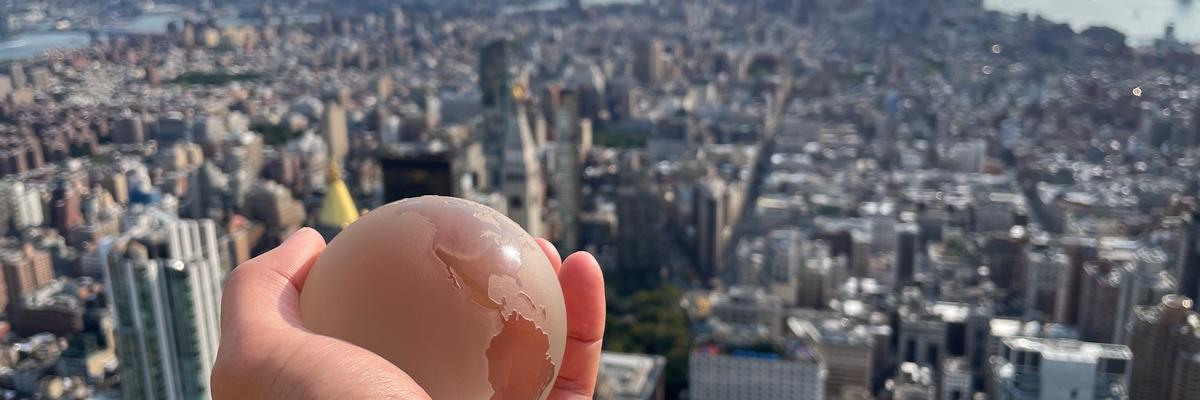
xmin=0 ymin=0 xmax=1200 ymax=400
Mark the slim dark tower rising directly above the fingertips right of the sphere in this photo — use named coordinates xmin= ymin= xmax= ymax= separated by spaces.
xmin=554 ymin=89 xmax=583 ymax=253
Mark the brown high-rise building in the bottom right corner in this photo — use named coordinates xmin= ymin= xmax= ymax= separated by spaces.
xmin=1129 ymin=294 xmax=1200 ymax=400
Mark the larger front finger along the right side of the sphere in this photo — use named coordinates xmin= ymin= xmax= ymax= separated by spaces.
xmin=551 ymin=251 xmax=605 ymax=399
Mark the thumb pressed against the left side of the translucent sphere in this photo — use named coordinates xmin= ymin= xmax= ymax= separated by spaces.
xmin=221 ymin=228 xmax=325 ymax=335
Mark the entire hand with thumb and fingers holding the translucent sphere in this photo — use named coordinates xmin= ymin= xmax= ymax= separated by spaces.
xmin=212 ymin=228 xmax=605 ymax=400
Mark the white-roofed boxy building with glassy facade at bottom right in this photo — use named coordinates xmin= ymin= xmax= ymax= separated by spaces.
xmin=991 ymin=338 xmax=1136 ymax=400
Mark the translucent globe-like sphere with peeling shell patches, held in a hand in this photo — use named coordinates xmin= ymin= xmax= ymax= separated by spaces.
xmin=300 ymin=196 xmax=566 ymax=399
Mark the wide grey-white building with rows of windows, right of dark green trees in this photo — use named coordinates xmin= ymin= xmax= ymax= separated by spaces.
xmin=688 ymin=344 xmax=827 ymax=400
